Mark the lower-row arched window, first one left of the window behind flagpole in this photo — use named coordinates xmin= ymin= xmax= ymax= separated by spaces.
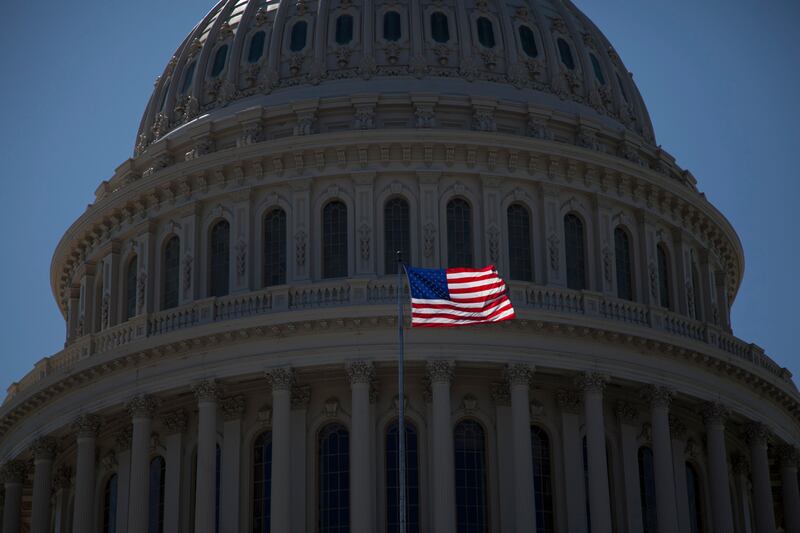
xmin=319 ymin=423 xmax=350 ymax=533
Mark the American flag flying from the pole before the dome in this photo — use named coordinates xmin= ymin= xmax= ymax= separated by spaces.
xmin=406 ymin=265 xmax=514 ymax=327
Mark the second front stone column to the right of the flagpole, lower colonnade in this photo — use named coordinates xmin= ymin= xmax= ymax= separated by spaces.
xmin=506 ymin=364 xmax=536 ymax=533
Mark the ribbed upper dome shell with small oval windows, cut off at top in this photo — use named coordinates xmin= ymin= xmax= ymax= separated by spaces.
xmin=136 ymin=0 xmax=654 ymax=154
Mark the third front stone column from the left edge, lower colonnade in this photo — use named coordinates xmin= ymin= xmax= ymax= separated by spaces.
xmin=72 ymin=415 xmax=100 ymax=533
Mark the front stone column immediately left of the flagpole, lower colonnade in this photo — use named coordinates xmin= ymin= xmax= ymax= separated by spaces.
xmin=345 ymin=361 xmax=374 ymax=533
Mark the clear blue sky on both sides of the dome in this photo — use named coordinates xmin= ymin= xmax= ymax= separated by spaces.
xmin=0 ymin=0 xmax=800 ymax=390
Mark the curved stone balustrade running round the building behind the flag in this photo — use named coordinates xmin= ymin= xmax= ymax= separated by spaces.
xmin=6 ymin=276 xmax=794 ymax=401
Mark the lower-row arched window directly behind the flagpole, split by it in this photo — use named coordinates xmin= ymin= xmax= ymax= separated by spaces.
xmin=386 ymin=420 xmax=420 ymax=533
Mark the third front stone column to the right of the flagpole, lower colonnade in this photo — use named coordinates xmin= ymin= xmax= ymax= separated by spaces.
xmin=577 ymin=372 xmax=611 ymax=533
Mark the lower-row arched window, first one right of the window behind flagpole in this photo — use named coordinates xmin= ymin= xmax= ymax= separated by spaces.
xmin=453 ymin=420 xmax=489 ymax=533
